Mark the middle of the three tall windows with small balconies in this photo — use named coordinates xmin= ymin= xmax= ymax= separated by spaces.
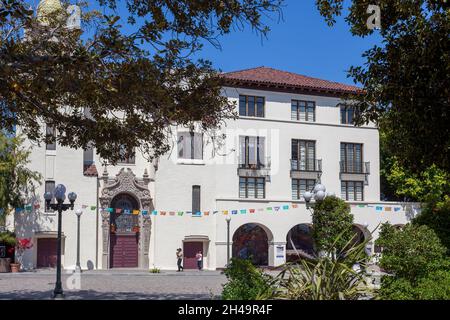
xmin=291 ymin=139 xmax=318 ymax=171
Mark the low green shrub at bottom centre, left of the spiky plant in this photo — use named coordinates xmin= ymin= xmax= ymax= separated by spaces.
xmin=222 ymin=258 xmax=273 ymax=300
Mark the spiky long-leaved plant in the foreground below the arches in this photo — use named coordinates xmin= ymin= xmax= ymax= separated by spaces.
xmin=260 ymin=230 xmax=370 ymax=300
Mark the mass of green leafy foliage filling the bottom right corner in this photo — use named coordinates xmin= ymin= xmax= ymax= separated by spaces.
xmin=376 ymin=224 xmax=450 ymax=300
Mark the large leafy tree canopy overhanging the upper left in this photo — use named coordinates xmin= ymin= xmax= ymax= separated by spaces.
xmin=0 ymin=0 xmax=282 ymax=162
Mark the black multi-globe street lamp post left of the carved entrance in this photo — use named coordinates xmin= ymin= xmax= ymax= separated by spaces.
xmin=44 ymin=184 xmax=77 ymax=299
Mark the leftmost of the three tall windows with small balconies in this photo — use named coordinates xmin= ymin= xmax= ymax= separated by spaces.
xmin=239 ymin=136 xmax=266 ymax=169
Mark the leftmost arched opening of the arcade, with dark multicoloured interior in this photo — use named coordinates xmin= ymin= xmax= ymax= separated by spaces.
xmin=233 ymin=223 xmax=269 ymax=266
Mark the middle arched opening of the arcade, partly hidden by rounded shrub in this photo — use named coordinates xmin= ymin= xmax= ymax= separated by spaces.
xmin=286 ymin=224 xmax=314 ymax=262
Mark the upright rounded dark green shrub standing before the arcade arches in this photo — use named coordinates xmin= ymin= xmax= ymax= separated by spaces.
xmin=312 ymin=197 xmax=354 ymax=252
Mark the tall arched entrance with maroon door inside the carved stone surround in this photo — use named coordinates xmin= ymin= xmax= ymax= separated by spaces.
xmin=109 ymin=193 xmax=140 ymax=268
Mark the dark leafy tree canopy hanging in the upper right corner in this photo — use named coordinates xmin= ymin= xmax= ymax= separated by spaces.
xmin=316 ymin=0 xmax=450 ymax=172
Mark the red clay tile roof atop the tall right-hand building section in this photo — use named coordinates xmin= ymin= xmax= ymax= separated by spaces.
xmin=221 ymin=67 xmax=362 ymax=95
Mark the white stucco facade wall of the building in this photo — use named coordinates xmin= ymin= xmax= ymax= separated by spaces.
xmin=9 ymin=88 xmax=418 ymax=269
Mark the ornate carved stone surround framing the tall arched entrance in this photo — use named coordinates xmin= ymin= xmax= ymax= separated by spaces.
xmin=99 ymin=168 xmax=153 ymax=269
